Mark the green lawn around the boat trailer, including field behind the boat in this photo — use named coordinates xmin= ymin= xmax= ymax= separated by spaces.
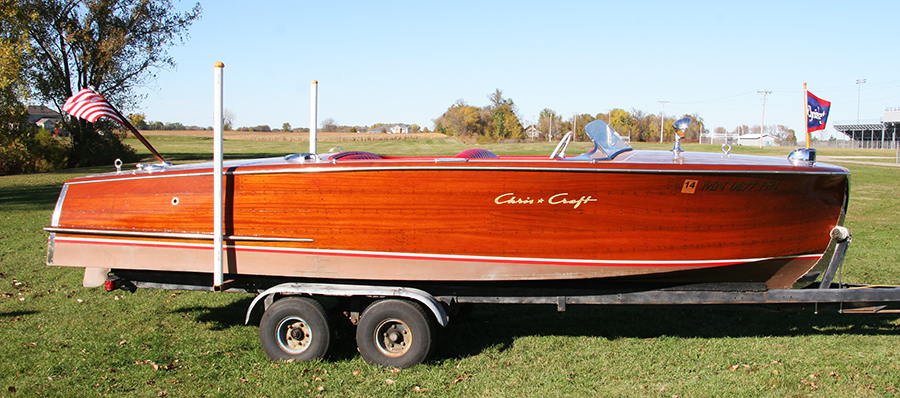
xmin=0 ymin=137 xmax=900 ymax=398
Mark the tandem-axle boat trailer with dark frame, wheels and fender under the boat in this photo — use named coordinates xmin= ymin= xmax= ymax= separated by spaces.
xmin=106 ymin=228 xmax=900 ymax=368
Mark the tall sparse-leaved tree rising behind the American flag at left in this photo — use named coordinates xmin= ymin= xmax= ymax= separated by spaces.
xmin=21 ymin=0 xmax=200 ymax=166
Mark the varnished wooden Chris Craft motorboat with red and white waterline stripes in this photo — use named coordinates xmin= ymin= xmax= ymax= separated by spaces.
xmin=46 ymin=121 xmax=849 ymax=288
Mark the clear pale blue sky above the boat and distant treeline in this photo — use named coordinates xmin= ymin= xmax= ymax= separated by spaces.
xmin=132 ymin=0 xmax=900 ymax=141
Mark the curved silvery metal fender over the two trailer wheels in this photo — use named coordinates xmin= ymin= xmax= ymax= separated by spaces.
xmin=244 ymin=283 xmax=450 ymax=326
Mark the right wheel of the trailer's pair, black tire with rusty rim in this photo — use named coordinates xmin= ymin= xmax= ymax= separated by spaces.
xmin=356 ymin=299 xmax=434 ymax=368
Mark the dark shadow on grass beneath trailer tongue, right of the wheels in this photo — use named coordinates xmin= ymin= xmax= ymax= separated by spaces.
xmin=431 ymin=305 xmax=900 ymax=360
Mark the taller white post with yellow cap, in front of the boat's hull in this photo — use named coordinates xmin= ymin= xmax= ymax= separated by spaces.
xmin=213 ymin=62 xmax=225 ymax=291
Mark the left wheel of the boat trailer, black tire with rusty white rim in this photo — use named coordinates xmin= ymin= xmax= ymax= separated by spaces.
xmin=259 ymin=297 xmax=332 ymax=361
